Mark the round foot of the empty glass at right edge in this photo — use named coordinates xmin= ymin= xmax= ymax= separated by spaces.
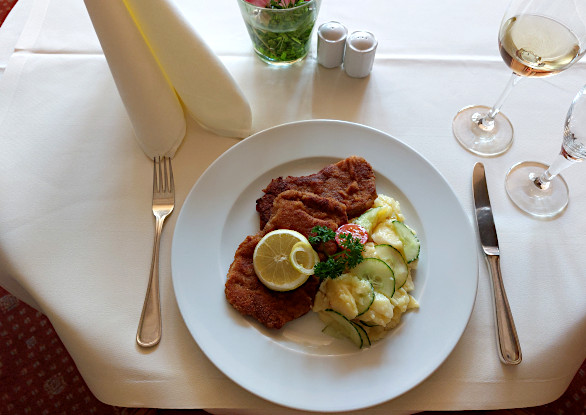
xmin=505 ymin=161 xmax=569 ymax=219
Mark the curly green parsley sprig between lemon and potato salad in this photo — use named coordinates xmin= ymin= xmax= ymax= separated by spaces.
xmin=308 ymin=226 xmax=364 ymax=280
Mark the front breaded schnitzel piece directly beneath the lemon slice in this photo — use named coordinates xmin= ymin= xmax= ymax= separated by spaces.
xmin=224 ymin=190 xmax=348 ymax=329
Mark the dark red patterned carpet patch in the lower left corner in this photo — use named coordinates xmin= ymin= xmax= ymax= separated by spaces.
xmin=0 ymin=288 xmax=131 ymax=415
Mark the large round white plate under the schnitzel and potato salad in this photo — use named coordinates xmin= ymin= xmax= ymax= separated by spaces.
xmin=172 ymin=120 xmax=478 ymax=412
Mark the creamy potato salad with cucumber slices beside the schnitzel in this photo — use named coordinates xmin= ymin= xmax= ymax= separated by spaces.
xmin=313 ymin=195 xmax=420 ymax=347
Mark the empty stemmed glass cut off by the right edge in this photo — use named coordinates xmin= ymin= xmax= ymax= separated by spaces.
xmin=505 ymin=85 xmax=586 ymax=218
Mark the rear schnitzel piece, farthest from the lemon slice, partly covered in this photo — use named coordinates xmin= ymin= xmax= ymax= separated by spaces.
xmin=256 ymin=156 xmax=377 ymax=229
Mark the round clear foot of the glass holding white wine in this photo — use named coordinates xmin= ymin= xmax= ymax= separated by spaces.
xmin=452 ymin=105 xmax=513 ymax=157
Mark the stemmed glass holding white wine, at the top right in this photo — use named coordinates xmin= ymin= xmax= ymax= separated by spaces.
xmin=452 ymin=0 xmax=586 ymax=157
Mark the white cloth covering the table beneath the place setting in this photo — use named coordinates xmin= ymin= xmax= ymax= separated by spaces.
xmin=0 ymin=0 xmax=586 ymax=413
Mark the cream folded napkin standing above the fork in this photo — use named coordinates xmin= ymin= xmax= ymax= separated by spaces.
xmin=84 ymin=0 xmax=252 ymax=158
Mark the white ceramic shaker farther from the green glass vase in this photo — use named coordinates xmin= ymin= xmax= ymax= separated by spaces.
xmin=344 ymin=31 xmax=378 ymax=78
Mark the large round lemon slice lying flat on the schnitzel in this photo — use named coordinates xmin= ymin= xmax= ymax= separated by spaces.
xmin=252 ymin=229 xmax=309 ymax=291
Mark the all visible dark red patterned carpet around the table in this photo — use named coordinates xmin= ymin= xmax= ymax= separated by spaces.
xmin=0 ymin=0 xmax=586 ymax=415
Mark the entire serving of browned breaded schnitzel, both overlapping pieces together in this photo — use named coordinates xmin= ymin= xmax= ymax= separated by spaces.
xmin=225 ymin=156 xmax=377 ymax=329
